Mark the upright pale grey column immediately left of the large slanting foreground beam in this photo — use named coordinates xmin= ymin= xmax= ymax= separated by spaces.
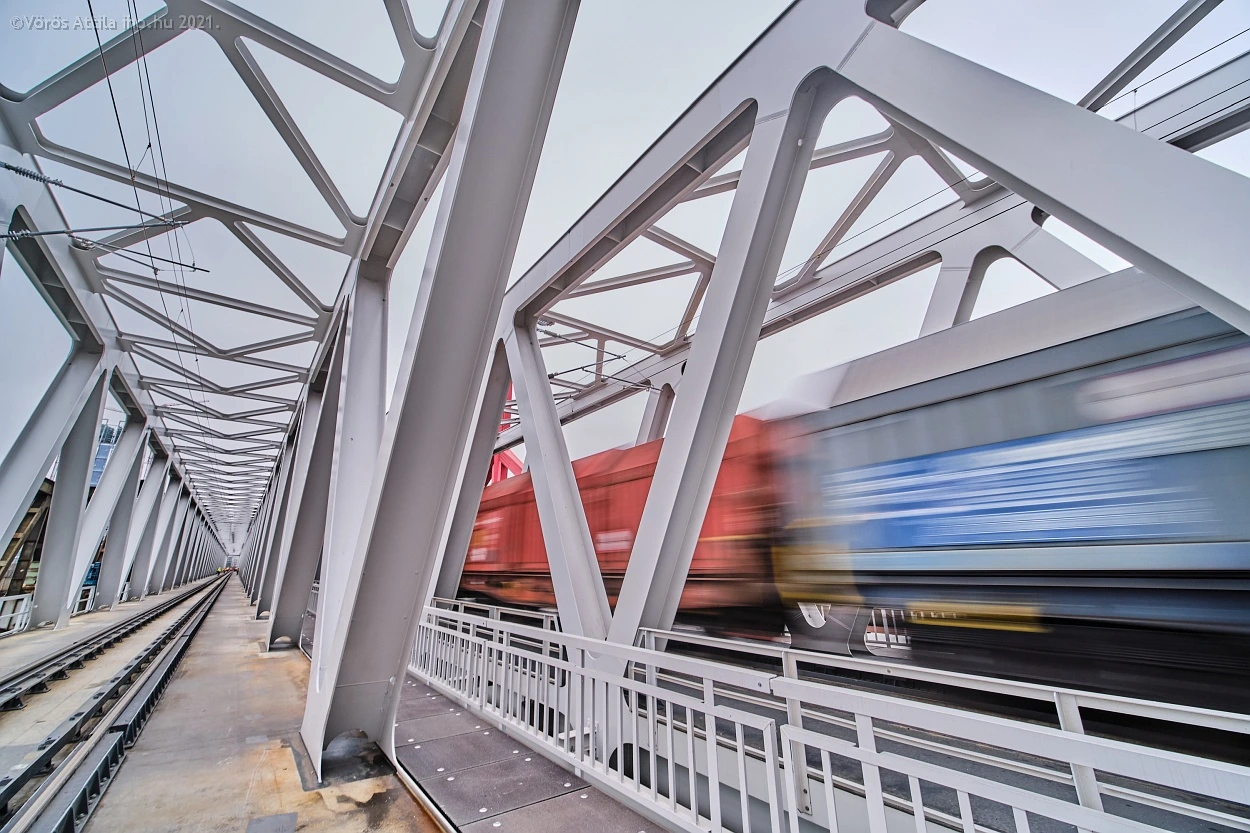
xmin=311 ymin=275 xmax=386 ymax=688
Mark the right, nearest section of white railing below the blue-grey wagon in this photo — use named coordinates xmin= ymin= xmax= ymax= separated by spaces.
xmin=774 ymin=679 xmax=1250 ymax=833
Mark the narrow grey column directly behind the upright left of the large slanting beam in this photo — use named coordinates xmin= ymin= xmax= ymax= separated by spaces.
xmin=269 ymin=340 xmax=343 ymax=647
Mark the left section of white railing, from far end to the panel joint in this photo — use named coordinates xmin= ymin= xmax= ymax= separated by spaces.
xmin=413 ymin=608 xmax=781 ymax=833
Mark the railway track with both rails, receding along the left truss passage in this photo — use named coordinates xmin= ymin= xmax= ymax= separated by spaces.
xmin=0 ymin=574 xmax=230 ymax=833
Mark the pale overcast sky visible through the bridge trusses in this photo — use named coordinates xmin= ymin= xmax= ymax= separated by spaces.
xmin=0 ymin=0 xmax=1250 ymax=470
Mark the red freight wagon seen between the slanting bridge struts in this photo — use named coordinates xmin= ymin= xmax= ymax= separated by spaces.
xmin=460 ymin=417 xmax=780 ymax=630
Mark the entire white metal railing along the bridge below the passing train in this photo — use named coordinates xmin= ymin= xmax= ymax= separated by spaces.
xmin=413 ymin=605 xmax=1250 ymax=833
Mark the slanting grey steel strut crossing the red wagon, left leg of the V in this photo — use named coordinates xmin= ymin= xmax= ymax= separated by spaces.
xmin=506 ymin=323 xmax=613 ymax=639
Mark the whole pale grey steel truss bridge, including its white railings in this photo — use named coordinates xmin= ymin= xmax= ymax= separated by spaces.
xmin=0 ymin=0 xmax=1250 ymax=833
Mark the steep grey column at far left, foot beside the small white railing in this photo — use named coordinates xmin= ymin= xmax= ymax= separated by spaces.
xmin=30 ymin=373 xmax=109 ymax=628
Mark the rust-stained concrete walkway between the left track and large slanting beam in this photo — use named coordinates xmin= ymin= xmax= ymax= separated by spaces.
xmin=85 ymin=579 xmax=439 ymax=833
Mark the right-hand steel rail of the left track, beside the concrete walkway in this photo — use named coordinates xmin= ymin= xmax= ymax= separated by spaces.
xmin=0 ymin=577 xmax=229 ymax=833
